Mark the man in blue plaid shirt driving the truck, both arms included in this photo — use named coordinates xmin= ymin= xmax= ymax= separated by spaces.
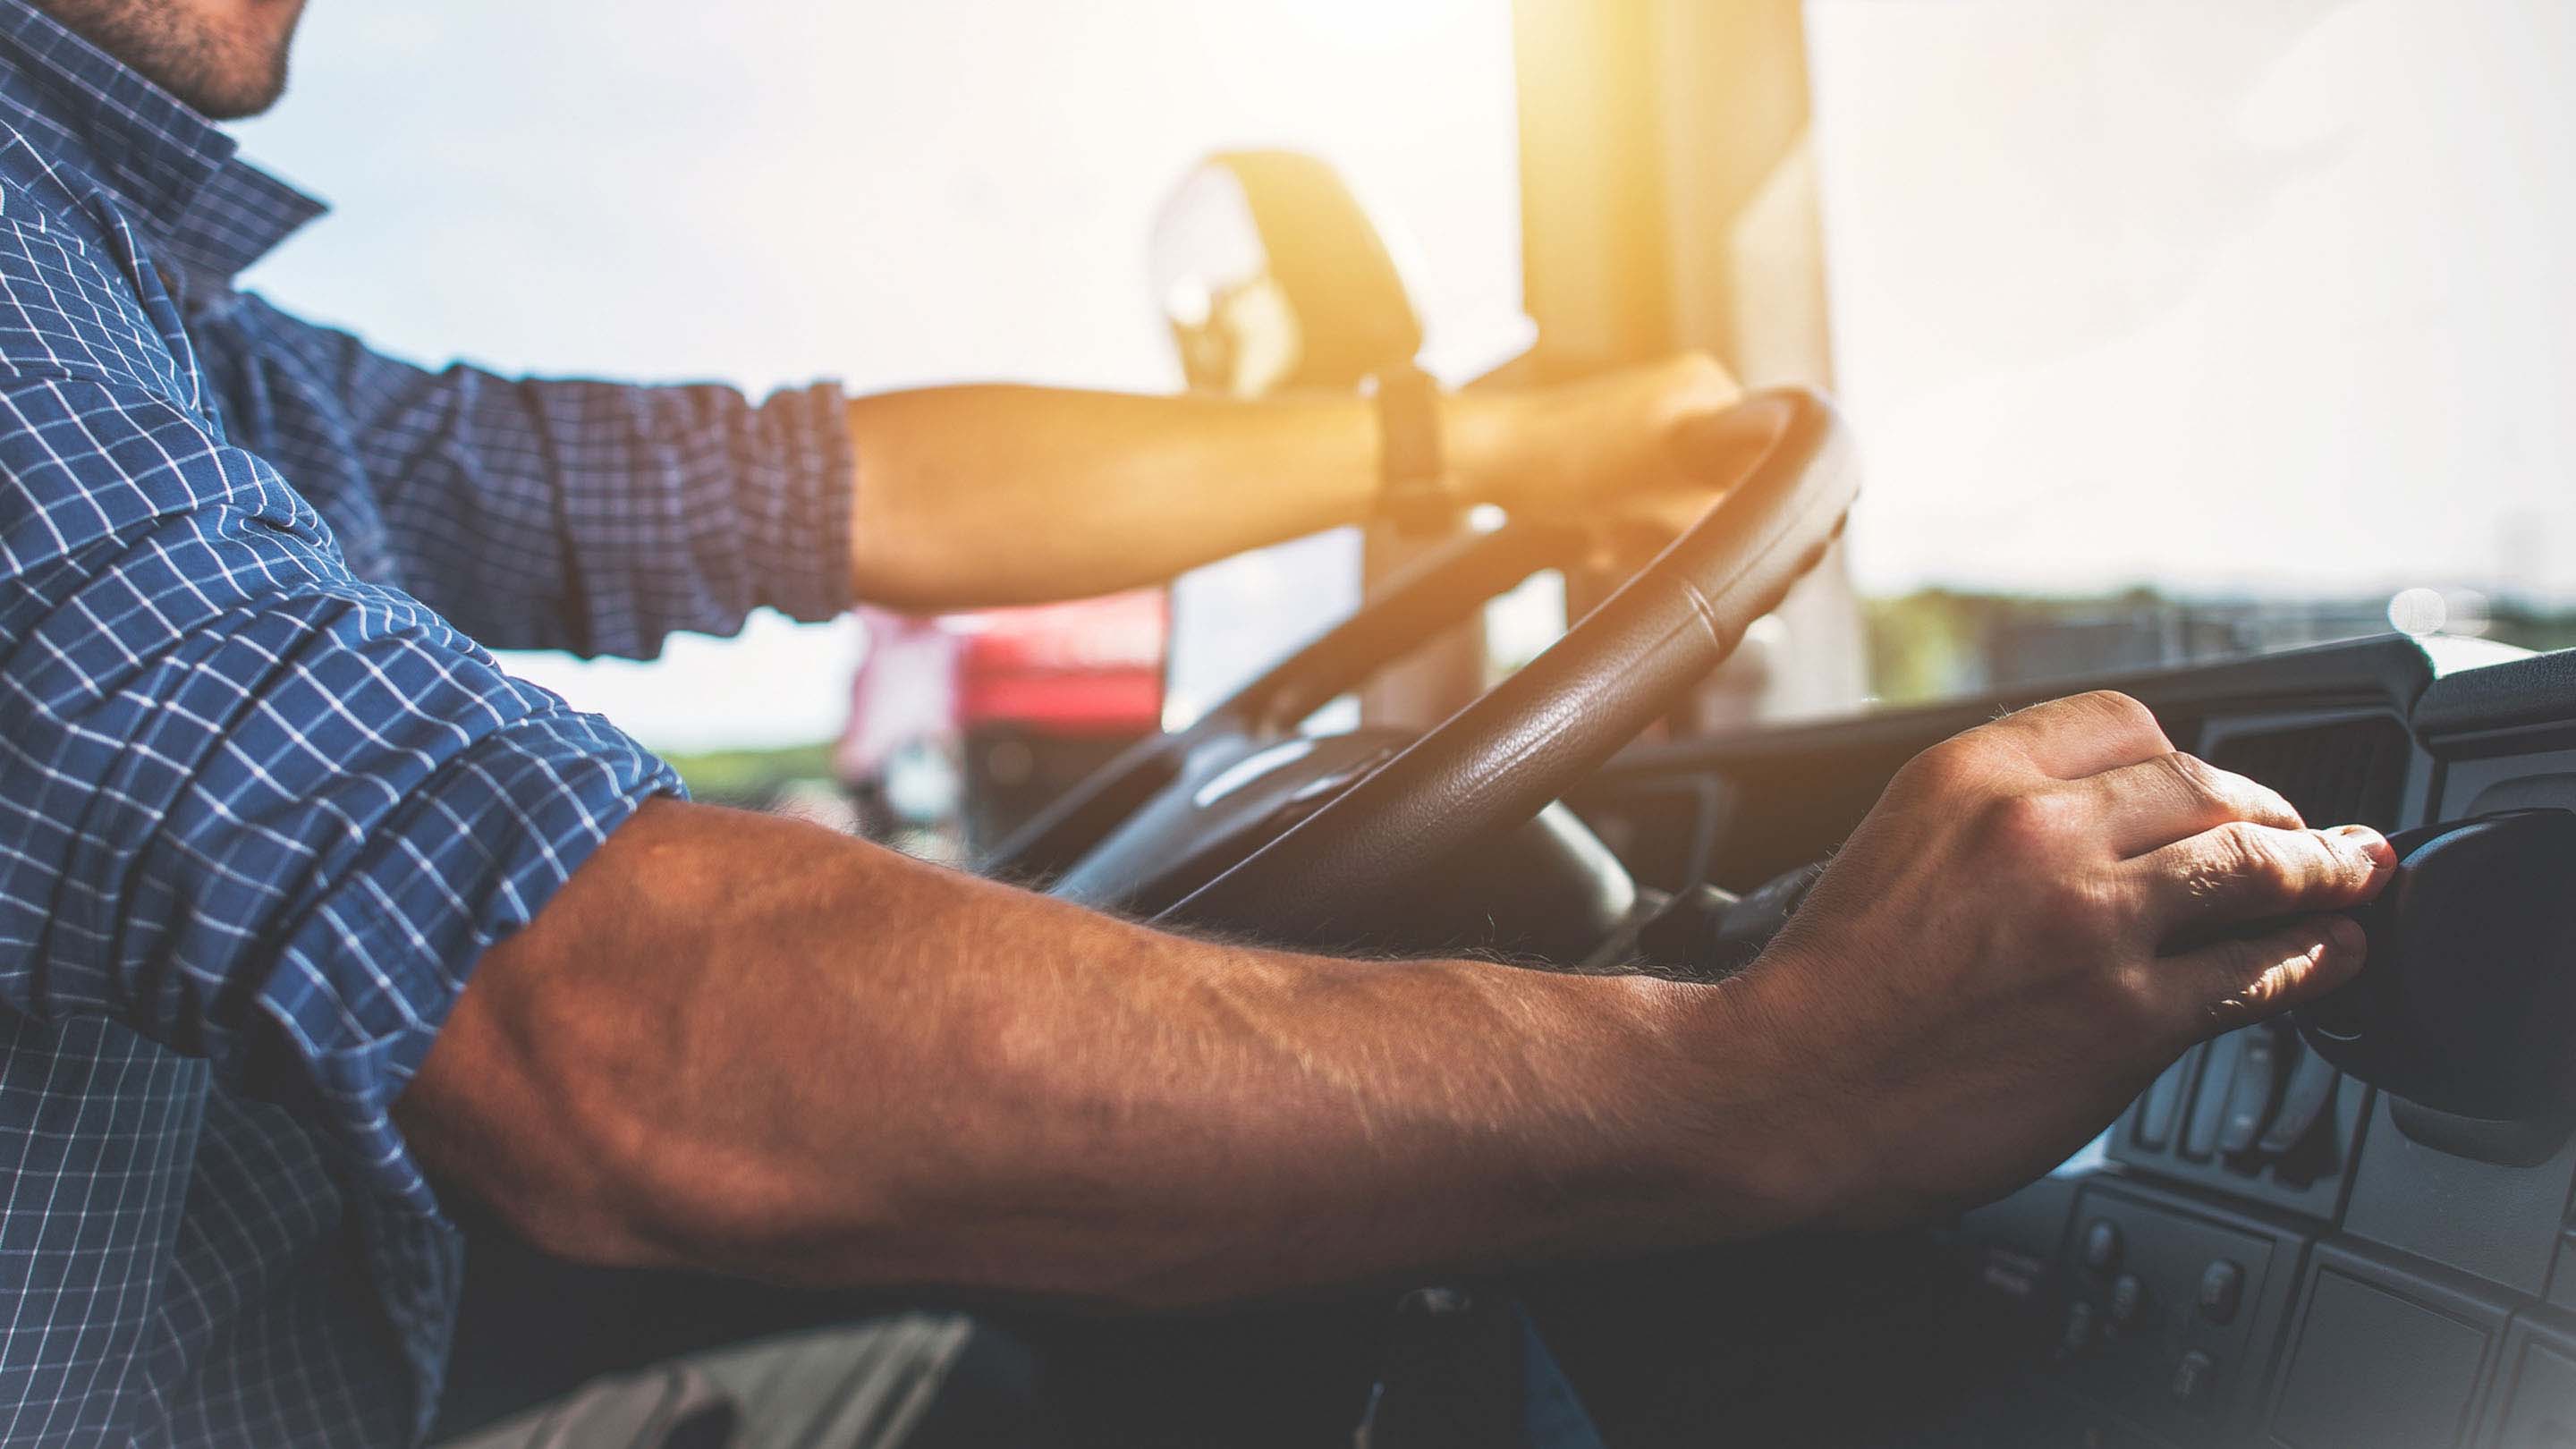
xmin=0 ymin=0 xmax=2388 ymax=1446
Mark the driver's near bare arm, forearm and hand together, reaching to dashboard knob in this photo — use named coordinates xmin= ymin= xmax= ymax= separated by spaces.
xmin=397 ymin=693 xmax=2388 ymax=1305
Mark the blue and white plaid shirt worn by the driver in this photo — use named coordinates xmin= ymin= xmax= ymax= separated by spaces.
xmin=0 ymin=0 xmax=850 ymax=1449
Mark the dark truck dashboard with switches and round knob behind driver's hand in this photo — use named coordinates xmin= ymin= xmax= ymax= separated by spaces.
xmin=1566 ymin=640 xmax=2576 ymax=1449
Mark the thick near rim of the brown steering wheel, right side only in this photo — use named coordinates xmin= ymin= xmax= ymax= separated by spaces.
xmin=1157 ymin=386 xmax=1860 ymax=944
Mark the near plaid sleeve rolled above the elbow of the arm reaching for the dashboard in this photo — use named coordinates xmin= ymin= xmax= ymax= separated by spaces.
xmin=0 ymin=366 xmax=677 ymax=1209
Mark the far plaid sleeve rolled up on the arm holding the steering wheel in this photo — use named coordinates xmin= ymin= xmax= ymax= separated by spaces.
xmin=204 ymin=296 xmax=855 ymax=657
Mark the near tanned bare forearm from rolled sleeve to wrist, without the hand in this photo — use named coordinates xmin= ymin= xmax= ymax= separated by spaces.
xmin=402 ymin=804 xmax=1795 ymax=1305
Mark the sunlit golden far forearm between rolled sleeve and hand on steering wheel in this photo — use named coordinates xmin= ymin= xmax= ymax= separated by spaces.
xmin=850 ymin=386 xmax=1492 ymax=608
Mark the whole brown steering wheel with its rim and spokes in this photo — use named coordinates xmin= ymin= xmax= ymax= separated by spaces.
xmin=984 ymin=389 xmax=1857 ymax=944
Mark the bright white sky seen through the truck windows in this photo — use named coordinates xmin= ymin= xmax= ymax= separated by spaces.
xmin=242 ymin=0 xmax=2576 ymax=748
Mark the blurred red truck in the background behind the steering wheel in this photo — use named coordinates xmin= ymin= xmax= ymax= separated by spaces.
xmin=832 ymin=588 xmax=1170 ymax=861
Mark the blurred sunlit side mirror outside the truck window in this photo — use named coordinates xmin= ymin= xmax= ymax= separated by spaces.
xmin=1151 ymin=152 xmax=1422 ymax=397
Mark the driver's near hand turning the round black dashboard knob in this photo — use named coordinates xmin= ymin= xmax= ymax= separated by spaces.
xmin=1736 ymin=693 xmax=2394 ymax=1222
